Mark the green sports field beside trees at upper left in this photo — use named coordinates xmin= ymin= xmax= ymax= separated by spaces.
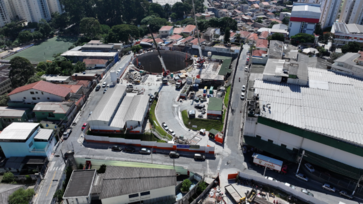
xmin=5 ymin=37 xmax=77 ymax=62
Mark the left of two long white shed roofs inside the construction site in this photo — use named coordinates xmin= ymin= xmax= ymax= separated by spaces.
xmin=89 ymin=85 xmax=126 ymax=124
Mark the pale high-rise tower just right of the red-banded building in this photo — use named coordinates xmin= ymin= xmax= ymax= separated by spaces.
xmin=320 ymin=0 xmax=342 ymax=29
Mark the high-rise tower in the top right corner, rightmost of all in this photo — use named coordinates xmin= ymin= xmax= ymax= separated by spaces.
xmin=339 ymin=0 xmax=363 ymax=25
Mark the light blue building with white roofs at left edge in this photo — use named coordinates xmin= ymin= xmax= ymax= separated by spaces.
xmin=0 ymin=122 xmax=56 ymax=159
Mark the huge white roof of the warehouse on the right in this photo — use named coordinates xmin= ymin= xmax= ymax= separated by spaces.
xmin=254 ymin=68 xmax=363 ymax=145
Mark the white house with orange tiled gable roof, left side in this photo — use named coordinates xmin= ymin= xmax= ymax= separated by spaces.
xmin=8 ymin=81 xmax=72 ymax=105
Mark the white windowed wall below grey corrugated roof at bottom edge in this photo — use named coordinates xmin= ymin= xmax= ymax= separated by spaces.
xmin=102 ymin=186 xmax=175 ymax=204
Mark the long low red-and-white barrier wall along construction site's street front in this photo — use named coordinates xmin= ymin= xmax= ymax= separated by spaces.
xmin=84 ymin=135 xmax=215 ymax=155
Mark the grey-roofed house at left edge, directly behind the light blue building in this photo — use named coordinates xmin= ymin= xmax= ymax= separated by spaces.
xmin=0 ymin=106 xmax=29 ymax=130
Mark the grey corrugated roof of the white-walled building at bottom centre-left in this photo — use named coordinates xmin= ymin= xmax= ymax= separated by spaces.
xmin=100 ymin=166 xmax=176 ymax=199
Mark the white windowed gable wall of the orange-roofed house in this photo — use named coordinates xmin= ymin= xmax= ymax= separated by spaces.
xmin=9 ymin=89 xmax=65 ymax=103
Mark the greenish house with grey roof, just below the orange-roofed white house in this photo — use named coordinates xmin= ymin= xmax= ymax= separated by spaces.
xmin=33 ymin=102 xmax=77 ymax=126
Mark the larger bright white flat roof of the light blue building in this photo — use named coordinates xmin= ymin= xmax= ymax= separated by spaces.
xmin=0 ymin=122 xmax=39 ymax=140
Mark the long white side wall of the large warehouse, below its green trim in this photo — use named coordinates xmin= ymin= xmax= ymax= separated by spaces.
xmin=255 ymin=124 xmax=363 ymax=168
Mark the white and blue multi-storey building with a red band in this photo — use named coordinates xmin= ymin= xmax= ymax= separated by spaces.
xmin=289 ymin=4 xmax=321 ymax=37
